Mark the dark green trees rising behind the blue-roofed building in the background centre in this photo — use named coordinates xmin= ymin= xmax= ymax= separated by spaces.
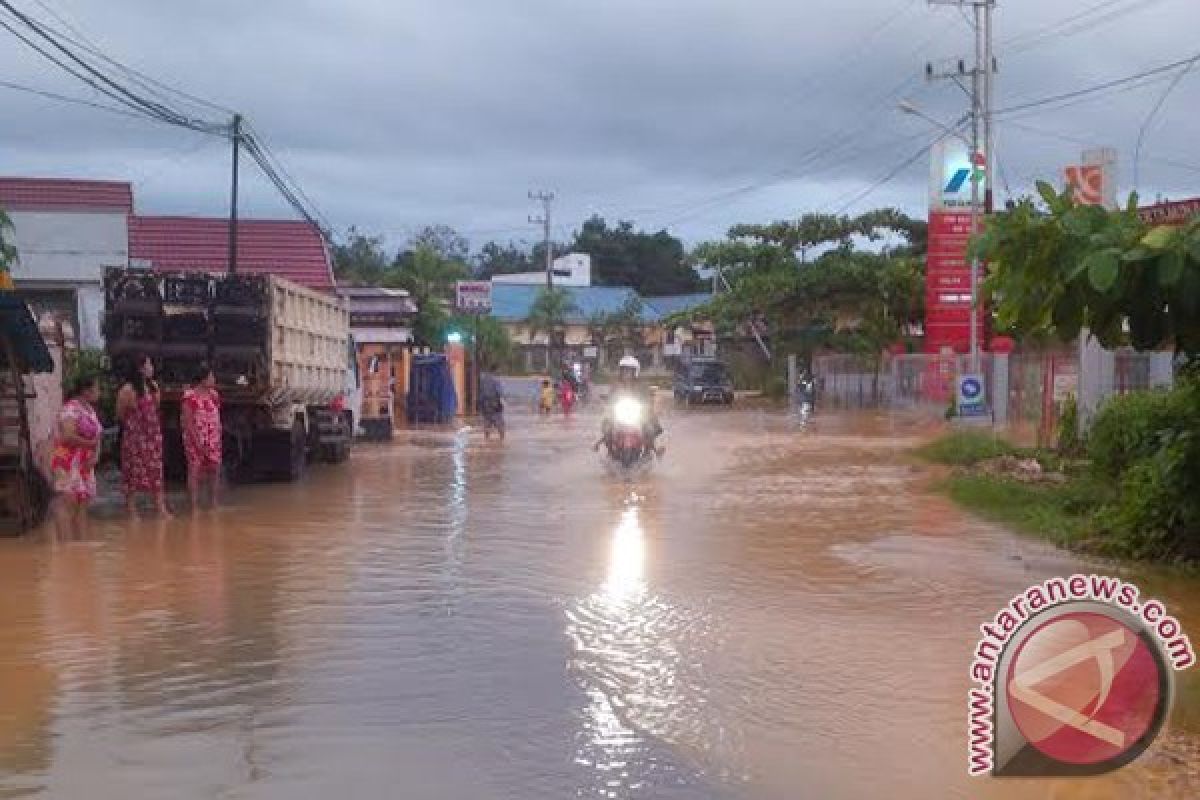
xmin=570 ymin=216 xmax=700 ymax=296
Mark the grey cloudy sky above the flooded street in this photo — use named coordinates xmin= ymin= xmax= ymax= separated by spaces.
xmin=0 ymin=0 xmax=1200 ymax=250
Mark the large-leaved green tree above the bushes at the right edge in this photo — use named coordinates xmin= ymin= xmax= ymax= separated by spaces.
xmin=973 ymin=182 xmax=1200 ymax=356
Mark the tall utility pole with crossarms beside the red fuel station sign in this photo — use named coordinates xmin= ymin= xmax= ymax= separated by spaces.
xmin=925 ymin=0 xmax=996 ymax=373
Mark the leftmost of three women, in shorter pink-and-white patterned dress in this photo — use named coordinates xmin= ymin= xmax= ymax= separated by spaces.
xmin=43 ymin=378 xmax=103 ymax=537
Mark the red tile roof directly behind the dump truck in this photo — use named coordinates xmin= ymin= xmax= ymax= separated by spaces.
xmin=130 ymin=216 xmax=335 ymax=291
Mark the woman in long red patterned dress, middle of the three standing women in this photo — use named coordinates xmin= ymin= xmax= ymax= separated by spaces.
xmin=116 ymin=356 xmax=170 ymax=517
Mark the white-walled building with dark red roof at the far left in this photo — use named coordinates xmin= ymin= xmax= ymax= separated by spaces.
xmin=0 ymin=178 xmax=133 ymax=348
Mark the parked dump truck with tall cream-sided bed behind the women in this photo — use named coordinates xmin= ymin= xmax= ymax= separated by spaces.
xmin=104 ymin=267 xmax=358 ymax=481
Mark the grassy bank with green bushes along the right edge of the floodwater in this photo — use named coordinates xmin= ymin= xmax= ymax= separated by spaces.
xmin=918 ymin=375 xmax=1200 ymax=566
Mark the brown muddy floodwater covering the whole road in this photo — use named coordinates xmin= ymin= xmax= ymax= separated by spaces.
xmin=0 ymin=410 xmax=1200 ymax=800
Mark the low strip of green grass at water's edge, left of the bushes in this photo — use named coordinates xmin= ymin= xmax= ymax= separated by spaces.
xmin=946 ymin=475 xmax=1092 ymax=548
